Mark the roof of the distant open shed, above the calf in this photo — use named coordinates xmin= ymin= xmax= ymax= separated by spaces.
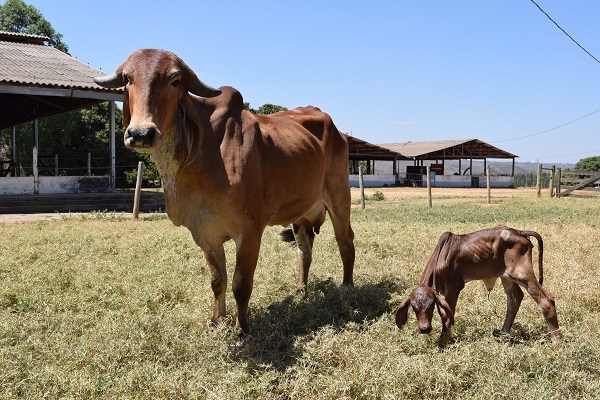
xmin=380 ymin=139 xmax=518 ymax=160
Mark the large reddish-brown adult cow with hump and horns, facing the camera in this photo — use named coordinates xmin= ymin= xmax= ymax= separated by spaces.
xmin=94 ymin=49 xmax=354 ymax=334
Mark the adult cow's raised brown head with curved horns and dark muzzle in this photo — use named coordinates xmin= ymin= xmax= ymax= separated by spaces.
xmin=94 ymin=49 xmax=221 ymax=161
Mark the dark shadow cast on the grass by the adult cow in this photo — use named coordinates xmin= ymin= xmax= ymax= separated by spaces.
xmin=232 ymin=279 xmax=403 ymax=371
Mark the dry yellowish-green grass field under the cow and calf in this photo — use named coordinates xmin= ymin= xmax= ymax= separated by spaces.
xmin=0 ymin=189 xmax=600 ymax=399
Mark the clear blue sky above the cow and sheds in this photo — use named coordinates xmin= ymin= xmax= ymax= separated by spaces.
xmin=25 ymin=0 xmax=600 ymax=164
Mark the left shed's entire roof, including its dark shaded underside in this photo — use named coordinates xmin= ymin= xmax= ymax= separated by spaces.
xmin=0 ymin=31 xmax=123 ymax=129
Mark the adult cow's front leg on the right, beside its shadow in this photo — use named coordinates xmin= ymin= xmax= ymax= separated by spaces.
xmin=232 ymin=230 xmax=262 ymax=335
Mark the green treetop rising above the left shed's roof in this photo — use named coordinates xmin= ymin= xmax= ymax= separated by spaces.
xmin=0 ymin=0 xmax=69 ymax=54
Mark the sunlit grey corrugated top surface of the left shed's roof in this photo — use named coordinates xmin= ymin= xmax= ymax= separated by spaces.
xmin=0 ymin=38 xmax=119 ymax=92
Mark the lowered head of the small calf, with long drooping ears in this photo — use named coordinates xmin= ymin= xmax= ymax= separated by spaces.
xmin=396 ymin=285 xmax=454 ymax=333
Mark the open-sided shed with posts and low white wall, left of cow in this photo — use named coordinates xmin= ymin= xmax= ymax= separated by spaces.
xmin=0 ymin=31 xmax=123 ymax=194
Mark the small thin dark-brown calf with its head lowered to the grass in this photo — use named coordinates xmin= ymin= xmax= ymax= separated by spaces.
xmin=396 ymin=226 xmax=561 ymax=342
